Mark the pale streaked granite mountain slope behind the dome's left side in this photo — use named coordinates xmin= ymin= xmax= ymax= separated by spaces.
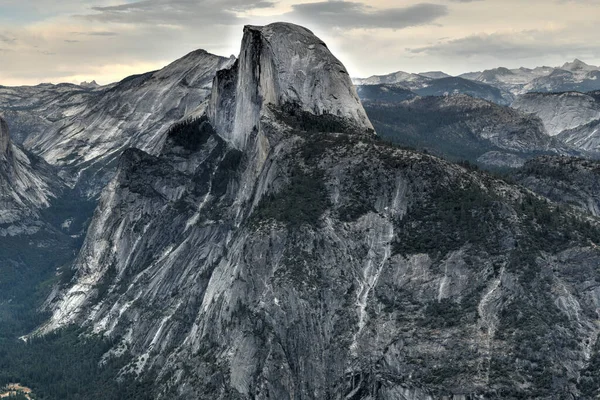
xmin=0 ymin=50 xmax=233 ymax=197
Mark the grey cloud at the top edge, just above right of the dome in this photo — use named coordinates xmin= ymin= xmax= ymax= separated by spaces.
xmin=287 ymin=1 xmax=448 ymax=29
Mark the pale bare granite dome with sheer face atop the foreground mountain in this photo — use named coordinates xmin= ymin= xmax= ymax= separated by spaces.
xmin=208 ymin=23 xmax=373 ymax=148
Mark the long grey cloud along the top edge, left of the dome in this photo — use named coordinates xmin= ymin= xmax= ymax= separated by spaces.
xmin=79 ymin=0 xmax=275 ymax=26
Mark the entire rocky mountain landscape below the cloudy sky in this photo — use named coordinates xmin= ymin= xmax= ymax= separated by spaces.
xmin=0 ymin=23 xmax=600 ymax=400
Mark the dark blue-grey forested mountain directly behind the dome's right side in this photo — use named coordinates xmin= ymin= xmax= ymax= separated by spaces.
xmin=358 ymin=92 xmax=570 ymax=168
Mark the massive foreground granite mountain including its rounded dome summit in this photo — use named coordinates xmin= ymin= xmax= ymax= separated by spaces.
xmin=41 ymin=24 xmax=600 ymax=400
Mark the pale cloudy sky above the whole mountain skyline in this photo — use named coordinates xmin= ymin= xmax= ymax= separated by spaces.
xmin=0 ymin=0 xmax=600 ymax=86
